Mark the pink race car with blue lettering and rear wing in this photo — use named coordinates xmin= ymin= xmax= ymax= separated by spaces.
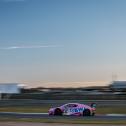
xmin=48 ymin=103 xmax=96 ymax=116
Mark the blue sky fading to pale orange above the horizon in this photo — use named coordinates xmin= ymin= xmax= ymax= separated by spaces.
xmin=0 ymin=0 xmax=126 ymax=87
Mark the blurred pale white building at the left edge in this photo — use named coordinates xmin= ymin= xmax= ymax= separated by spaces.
xmin=0 ymin=83 xmax=24 ymax=94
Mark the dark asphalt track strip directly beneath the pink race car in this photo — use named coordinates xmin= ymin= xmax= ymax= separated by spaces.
xmin=0 ymin=112 xmax=126 ymax=120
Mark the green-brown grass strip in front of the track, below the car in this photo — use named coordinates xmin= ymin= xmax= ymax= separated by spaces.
xmin=0 ymin=118 xmax=126 ymax=124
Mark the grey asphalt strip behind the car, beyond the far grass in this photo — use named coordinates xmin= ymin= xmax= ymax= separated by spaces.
xmin=0 ymin=99 xmax=126 ymax=107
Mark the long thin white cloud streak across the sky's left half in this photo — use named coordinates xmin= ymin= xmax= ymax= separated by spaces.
xmin=0 ymin=45 xmax=62 ymax=50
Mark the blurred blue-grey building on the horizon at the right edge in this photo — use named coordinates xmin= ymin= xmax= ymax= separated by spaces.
xmin=109 ymin=81 xmax=126 ymax=91
